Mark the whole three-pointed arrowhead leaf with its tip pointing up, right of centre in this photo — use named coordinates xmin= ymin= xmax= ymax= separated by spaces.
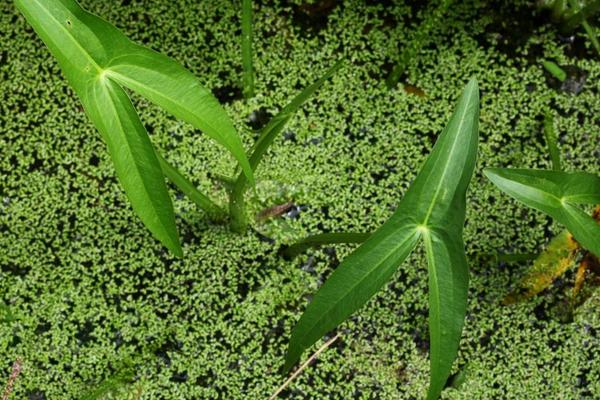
xmin=284 ymin=79 xmax=479 ymax=399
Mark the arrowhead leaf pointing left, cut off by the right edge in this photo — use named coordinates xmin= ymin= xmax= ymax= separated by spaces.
xmin=484 ymin=168 xmax=600 ymax=256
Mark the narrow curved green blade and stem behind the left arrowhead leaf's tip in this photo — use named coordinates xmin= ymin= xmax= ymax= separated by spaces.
xmin=229 ymin=61 xmax=343 ymax=232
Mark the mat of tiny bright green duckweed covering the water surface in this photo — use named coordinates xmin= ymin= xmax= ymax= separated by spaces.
xmin=0 ymin=0 xmax=600 ymax=399
